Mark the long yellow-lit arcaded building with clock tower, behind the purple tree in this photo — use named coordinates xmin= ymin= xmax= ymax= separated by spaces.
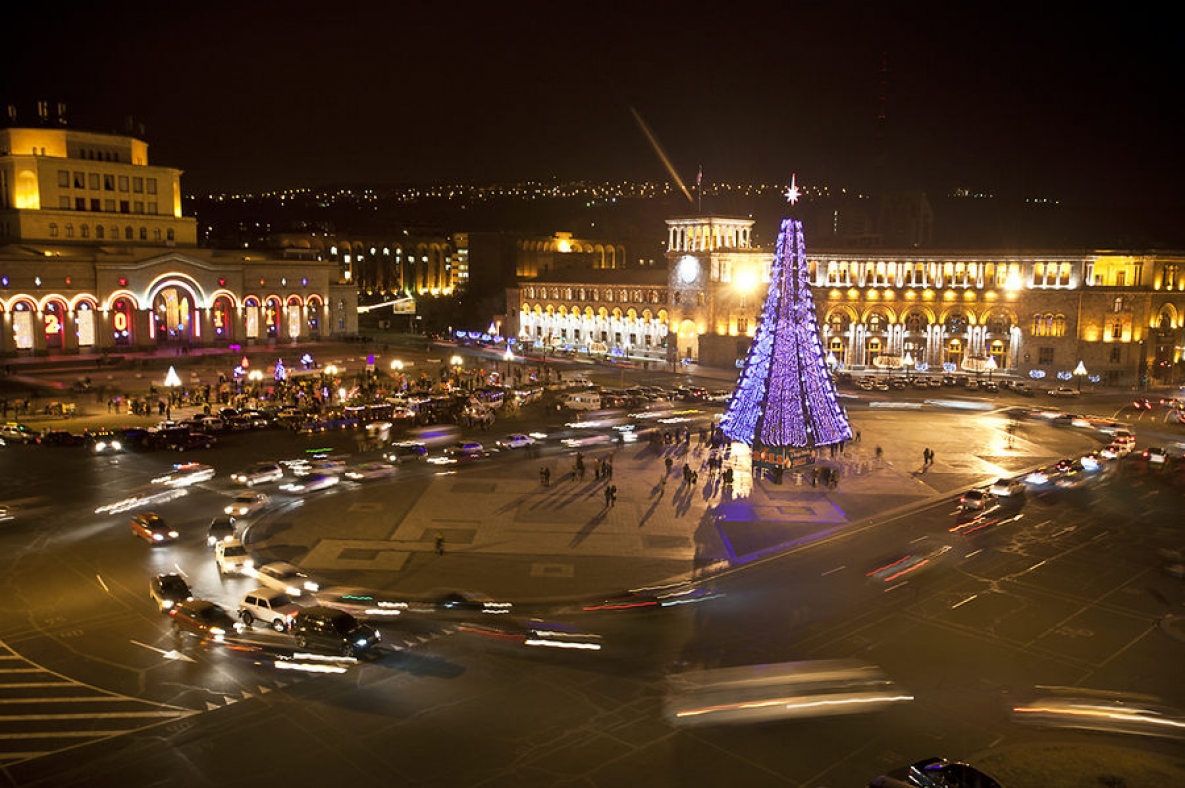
xmin=506 ymin=213 xmax=1185 ymax=386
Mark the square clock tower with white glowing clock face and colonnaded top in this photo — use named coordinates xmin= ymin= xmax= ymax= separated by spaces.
xmin=666 ymin=216 xmax=768 ymax=361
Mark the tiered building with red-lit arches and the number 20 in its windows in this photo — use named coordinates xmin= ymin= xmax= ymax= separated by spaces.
xmin=0 ymin=113 xmax=358 ymax=355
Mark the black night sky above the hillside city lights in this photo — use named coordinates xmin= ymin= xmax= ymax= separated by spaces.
xmin=0 ymin=0 xmax=1185 ymax=239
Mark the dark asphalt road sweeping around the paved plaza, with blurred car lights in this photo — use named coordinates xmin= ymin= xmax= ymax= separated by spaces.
xmin=0 ymin=353 xmax=1185 ymax=787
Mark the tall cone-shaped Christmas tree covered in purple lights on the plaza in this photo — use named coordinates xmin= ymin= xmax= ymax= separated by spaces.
xmin=720 ymin=219 xmax=852 ymax=448
